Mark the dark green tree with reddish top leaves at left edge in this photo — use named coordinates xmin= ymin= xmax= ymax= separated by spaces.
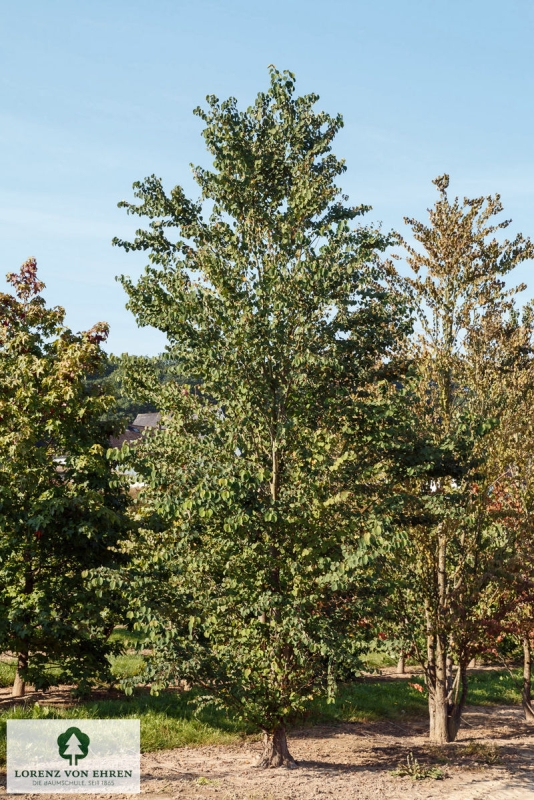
xmin=0 ymin=259 xmax=132 ymax=696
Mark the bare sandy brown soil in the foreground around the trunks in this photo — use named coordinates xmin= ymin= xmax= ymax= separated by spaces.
xmin=0 ymin=706 xmax=534 ymax=800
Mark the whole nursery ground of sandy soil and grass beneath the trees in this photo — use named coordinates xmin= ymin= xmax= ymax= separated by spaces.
xmin=0 ymin=668 xmax=534 ymax=800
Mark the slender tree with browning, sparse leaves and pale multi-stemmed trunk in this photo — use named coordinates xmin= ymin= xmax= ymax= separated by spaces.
xmin=384 ymin=175 xmax=534 ymax=742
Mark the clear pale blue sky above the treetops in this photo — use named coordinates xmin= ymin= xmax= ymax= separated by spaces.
xmin=0 ymin=0 xmax=534 ymax=355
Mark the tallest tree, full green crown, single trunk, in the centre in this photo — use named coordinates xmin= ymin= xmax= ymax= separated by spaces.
xmin=115 ymin=68 xmax=409 ymax=766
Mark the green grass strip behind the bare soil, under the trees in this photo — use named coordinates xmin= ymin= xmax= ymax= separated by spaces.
xmin=0 ymin=656 xmax=520 ymax=763
